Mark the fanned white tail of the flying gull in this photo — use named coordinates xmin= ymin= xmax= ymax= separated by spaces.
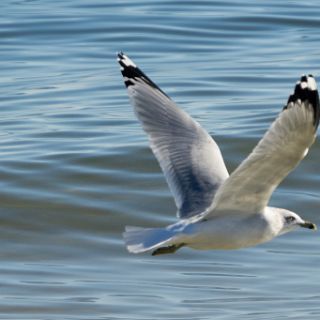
xmin=123 ymin=226 xmax=175 ymax=253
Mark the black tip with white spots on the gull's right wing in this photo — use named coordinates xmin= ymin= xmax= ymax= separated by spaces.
xmin=284 ymin=74 xmax=320 ymax=128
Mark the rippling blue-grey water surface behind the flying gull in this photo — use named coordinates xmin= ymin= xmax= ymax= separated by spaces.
xmin=0 ymin=0 xmax=320 ymax=320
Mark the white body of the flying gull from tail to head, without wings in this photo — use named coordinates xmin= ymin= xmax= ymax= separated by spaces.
xmin=124 ymin=207 xmax=305 ymax=253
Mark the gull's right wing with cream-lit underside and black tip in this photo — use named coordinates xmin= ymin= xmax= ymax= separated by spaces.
xmin=205 ymin=75 xmax=320 ymax=218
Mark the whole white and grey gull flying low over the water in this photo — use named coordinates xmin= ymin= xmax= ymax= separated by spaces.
xmin=118 ymin=52 xmax=320 ymax=255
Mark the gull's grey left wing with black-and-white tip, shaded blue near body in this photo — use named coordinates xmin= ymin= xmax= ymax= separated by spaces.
xmin=118 ymin=53 xmax=229 ymax=218
